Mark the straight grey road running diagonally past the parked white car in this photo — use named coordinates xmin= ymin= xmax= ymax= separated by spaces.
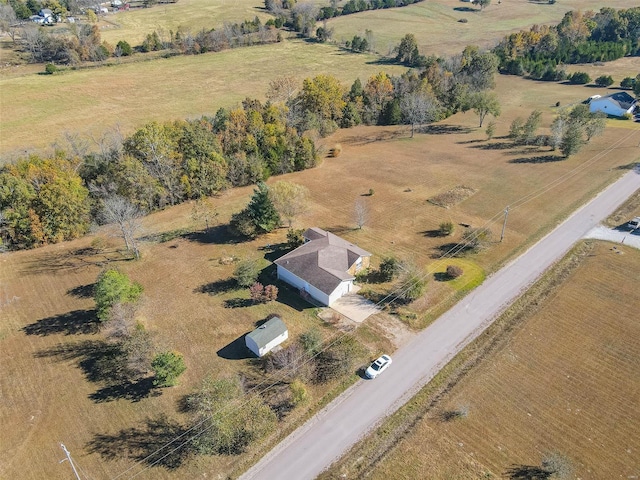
xmin=241 ymin=166 xmax=640 ymax=480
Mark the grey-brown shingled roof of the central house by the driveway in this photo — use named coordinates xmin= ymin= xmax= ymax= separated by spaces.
xmin=275 ymin=228 xmax=371 ymax=295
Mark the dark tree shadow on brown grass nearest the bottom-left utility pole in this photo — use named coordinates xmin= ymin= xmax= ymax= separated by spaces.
xmin=86 ymin=415 xmax=194 ymax=470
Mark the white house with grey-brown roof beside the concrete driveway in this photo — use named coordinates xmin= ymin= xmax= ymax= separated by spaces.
xmin=275 ymin=228 xmax=371 ymax=306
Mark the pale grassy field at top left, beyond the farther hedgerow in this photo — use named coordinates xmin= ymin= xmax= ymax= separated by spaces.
xmin=100 ymin=0 xmax=273 ymax=45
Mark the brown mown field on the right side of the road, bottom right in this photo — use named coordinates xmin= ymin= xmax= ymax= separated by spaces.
xmin=370 ymin=242 xmax=640 ymax=480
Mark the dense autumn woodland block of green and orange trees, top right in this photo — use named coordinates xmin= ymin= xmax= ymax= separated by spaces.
xmin=493 ymin=7 xmax=640 ymax=81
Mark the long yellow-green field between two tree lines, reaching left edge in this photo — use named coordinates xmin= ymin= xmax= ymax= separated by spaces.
xmin=0 ymin=40 xmax=405 ymax=154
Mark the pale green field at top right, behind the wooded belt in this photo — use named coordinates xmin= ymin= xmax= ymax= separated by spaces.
xmin=328 ymin=0 xmax=633 ymax=55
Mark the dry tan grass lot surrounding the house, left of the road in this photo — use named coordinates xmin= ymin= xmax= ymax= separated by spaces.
xmin=0 ymin=72 xmax=640 ymax=479
